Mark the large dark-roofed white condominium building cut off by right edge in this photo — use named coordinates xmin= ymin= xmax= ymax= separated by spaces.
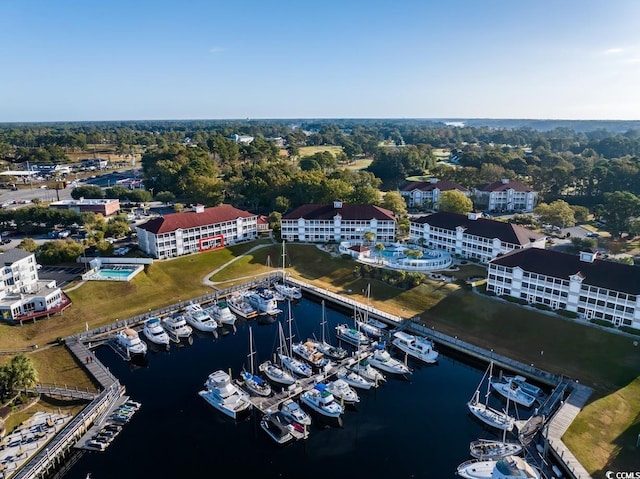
xmin=487 ymin=249 xmax=640 ymax=328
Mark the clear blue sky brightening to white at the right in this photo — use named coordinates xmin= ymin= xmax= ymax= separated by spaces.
xmin=0 ymin=0 xmax=640 ymax=122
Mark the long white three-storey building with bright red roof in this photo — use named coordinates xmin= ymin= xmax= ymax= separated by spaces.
xmin=136 ymin=205 xmax=258 ymax=259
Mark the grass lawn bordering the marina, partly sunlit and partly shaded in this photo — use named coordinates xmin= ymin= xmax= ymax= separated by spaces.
xmin=0 ymin=241 xmax=640 ymax=472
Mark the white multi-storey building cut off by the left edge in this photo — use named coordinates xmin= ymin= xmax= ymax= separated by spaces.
xmin=0 ymin=248 xmax=71 ymax=321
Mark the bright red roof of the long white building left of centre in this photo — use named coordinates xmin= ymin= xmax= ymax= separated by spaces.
xmin=138 ymin=205 xmax=257 ymax=234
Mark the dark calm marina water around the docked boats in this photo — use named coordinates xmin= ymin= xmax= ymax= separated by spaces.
xmin=64 ymin=299 xmax=522 ymax=479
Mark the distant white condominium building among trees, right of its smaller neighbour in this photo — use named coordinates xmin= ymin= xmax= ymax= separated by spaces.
xmin=473 ymin=179 xmax=538 ymax=212
